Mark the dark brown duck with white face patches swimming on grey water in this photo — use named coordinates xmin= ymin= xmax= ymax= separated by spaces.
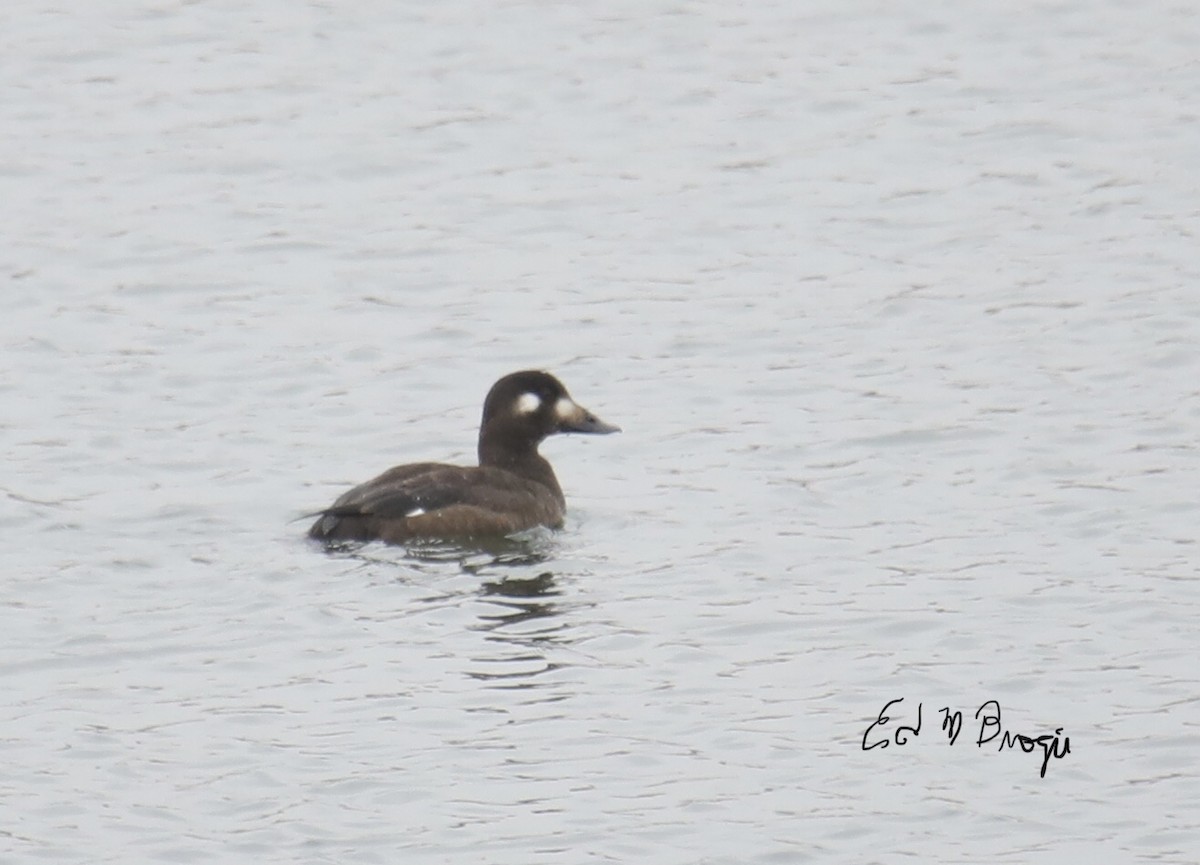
xmin=308 ymin=370 xmax=620 ymax=545
